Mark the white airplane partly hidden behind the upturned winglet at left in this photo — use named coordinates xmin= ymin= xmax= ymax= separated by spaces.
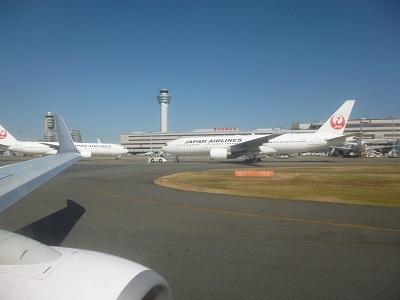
xmin=0 ymin=125 xmax=128 ymax=159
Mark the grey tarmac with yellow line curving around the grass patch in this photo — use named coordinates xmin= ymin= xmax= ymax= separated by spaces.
xmin=0 ymin=157 xmax=400 ymax=300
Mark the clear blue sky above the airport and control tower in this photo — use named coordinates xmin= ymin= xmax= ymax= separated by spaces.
xmin=0 ymin=0 xmax=400 ymax=143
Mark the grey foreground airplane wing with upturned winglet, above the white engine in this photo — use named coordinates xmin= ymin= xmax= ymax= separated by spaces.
xmin=0 ymin=116 xmax=81 ymax=213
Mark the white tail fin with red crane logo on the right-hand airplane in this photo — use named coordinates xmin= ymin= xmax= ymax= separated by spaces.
xmin=317 ymin=100 xmax=355 ymax=135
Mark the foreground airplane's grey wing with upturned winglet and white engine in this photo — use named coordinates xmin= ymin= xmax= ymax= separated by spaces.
xmin=0 ymin=116 xmax=172 ymax=300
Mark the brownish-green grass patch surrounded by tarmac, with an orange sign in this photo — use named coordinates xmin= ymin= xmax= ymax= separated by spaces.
xmin=155 ymin=166 xmax=400 ymax=207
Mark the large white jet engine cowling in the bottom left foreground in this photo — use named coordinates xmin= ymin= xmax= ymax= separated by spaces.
xmin=0 ymin=230 xmax=172 ymax=300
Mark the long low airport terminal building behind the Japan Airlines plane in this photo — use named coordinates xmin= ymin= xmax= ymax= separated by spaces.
xmin=120 ymin=119 xmax=400 ymax=154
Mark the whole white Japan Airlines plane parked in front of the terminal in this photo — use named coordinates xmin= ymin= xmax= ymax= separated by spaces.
xmin=161 ymin=100 xmax=355 ymax=162
